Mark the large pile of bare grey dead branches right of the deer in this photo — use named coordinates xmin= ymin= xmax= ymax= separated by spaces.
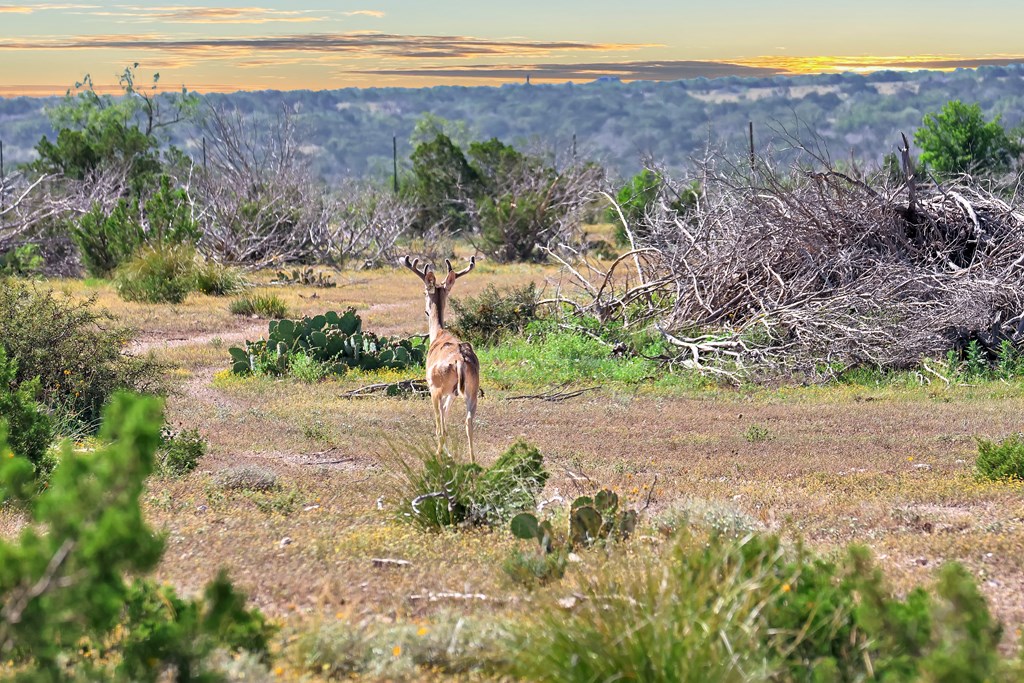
xmin=557 ymin=152 xmax=1024 ymax=377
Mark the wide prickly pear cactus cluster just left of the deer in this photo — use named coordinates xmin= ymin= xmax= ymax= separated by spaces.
xmin=228 ymin=308 xmax=426 ymax=375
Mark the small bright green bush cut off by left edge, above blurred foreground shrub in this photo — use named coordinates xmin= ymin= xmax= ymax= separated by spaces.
xmin=0 ymin=346 xmax=53 ymax=475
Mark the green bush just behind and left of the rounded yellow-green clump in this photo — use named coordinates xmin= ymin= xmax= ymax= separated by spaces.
xmin=69 ymin=199 xmax=145 ymax=278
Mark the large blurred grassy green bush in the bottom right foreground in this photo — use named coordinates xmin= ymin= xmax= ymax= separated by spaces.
xmin=510 ymin=529 xmax=1020 ymax=683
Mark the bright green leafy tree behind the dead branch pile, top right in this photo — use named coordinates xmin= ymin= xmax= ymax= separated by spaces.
xmin=913 ymin=99 xmax=1014 ymax=177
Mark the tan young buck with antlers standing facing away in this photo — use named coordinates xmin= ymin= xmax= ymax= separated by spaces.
xmin=401 ymin=256 xmax=480 ymax=463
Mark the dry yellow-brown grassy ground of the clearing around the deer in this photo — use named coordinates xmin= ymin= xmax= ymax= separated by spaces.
xmin=6 ymin=260 xmax=1024 ymax=678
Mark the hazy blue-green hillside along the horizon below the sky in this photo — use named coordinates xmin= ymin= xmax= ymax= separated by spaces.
xmin=0 ymin=65 xmax=1024 ymax=178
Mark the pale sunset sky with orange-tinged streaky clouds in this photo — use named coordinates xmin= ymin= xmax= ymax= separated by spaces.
xmin=0 ymin=0 xmax=1024 ymax=96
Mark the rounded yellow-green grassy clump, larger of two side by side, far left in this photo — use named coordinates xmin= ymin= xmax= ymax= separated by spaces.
xmin=114 ymin=245 xmax=196 ymax=303
